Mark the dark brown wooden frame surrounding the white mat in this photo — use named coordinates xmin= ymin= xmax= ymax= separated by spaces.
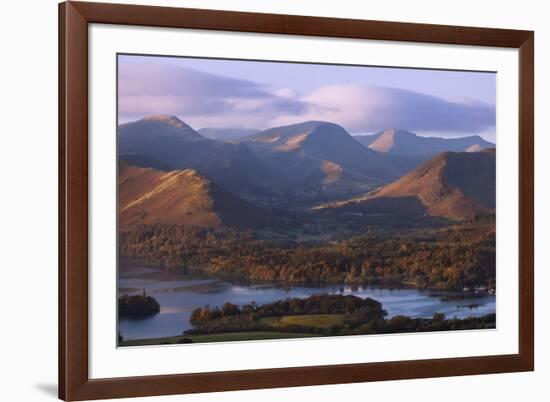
xmin=59 ymin=1 xmax=534 ymax=401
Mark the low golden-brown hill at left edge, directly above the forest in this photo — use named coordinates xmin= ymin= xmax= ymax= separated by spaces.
xmin=118 ymin=161 xmax=273 ymax=229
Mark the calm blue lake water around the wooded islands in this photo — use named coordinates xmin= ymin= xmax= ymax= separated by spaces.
xmin=118 ymin=266 xmax=495 ymax=339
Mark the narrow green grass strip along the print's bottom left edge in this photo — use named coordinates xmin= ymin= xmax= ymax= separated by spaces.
xmin=119 ymin=332 xmax=319 ymax=346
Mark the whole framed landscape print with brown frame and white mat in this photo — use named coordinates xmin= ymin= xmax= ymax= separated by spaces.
xmin=59 ymin=2 xmax=534 ymax=400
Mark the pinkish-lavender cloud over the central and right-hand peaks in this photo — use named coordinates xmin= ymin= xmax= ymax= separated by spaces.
xmin=275 ymin=85 xmax=496 ymax=134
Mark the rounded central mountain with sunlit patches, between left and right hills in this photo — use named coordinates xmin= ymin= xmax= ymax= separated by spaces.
xmin=240 ymin=121 xmax=403 ymax=191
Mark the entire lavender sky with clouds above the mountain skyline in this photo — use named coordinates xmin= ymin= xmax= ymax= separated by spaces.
xmin=118 ymin=55 xmax=496 ymax=142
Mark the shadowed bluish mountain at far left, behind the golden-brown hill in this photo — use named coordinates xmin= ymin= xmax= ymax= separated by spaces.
xmin=118 ymin=115 xmax=269 ymax=192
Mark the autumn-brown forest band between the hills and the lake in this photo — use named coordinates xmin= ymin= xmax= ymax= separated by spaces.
xmin=120 ymin=221 xmax=496 ymax=290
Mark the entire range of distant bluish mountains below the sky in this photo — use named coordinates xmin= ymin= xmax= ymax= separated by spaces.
xmin=117 ymin=115 xmax=498 ymax=207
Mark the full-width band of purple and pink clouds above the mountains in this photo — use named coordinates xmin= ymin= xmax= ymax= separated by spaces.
xmin=119 ymin=63 xmax=496 ymax=136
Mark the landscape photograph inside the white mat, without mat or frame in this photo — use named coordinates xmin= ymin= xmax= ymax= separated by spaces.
xmin=114 ymin=54 xmax=497 ymax=346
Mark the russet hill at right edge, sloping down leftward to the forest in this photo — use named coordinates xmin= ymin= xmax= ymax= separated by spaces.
xmin=321 ymin=148 xmax=496 ymax=218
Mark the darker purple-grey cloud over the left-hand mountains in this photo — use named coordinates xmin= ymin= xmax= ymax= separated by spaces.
xmin=118 ymin=64 xmax=306 ymax=127
